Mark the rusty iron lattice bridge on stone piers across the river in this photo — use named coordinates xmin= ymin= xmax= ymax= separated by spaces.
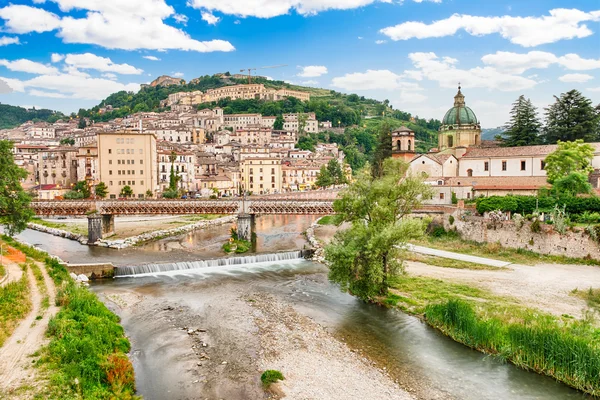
xmin=30 ymin=194 xmax=335 ymax=243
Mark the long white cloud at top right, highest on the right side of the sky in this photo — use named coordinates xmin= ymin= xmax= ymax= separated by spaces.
xmin=380 ymin=8 xmax=600 ymax=47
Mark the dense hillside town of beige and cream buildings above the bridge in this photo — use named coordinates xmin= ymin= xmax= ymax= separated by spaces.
xmin=0 ymin=84 xmax=344 ymax=199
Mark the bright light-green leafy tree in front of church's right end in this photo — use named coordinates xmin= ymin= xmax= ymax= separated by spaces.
xmin=545 ymin=139 xmax=594 ymax=184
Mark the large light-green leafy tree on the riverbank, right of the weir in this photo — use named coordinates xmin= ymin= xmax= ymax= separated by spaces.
xmin=325 ymin=159 xmax=432 ymax=300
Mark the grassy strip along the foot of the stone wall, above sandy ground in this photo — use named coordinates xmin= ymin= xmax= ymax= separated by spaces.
xmin=412 ymin=231 xmax=600 ymax=266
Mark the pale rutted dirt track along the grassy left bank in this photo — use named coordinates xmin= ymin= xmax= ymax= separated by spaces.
xmin=0 ymin=262 xmax=58 ymax=399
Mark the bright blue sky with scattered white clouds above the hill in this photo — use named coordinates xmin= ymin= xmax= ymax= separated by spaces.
xmin=0 ymin=0 xmax=600 ymax=128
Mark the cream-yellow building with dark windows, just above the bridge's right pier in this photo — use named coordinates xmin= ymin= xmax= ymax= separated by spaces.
xmin=240 ymin=157 xmax=282 ymax=194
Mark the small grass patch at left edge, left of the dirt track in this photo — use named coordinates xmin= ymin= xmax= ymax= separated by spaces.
xmin=0 ymin=265 xmax=31 ymax=346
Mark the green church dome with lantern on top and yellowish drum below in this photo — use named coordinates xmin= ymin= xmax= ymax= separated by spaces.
xmin=438 ymin=86 xmax=481 ymax=154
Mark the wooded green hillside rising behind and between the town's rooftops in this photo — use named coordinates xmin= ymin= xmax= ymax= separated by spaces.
xmin=79 ymin=75 xmax=441 ymax=171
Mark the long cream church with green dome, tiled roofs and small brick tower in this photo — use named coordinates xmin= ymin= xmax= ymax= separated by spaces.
xmin=392 ymin=86 xmax=600 ymax=204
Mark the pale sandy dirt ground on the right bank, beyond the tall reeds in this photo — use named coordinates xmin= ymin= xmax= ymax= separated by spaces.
xmin=406 ymin=262 xmax=600 ymax=318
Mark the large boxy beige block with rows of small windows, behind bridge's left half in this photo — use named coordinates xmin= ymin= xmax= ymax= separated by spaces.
xmin=98 ymin=132 xmax=158 ymax=199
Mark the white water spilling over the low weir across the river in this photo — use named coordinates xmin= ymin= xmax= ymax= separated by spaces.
xmin=115 ymin=250 xmax=306 ymax=278
